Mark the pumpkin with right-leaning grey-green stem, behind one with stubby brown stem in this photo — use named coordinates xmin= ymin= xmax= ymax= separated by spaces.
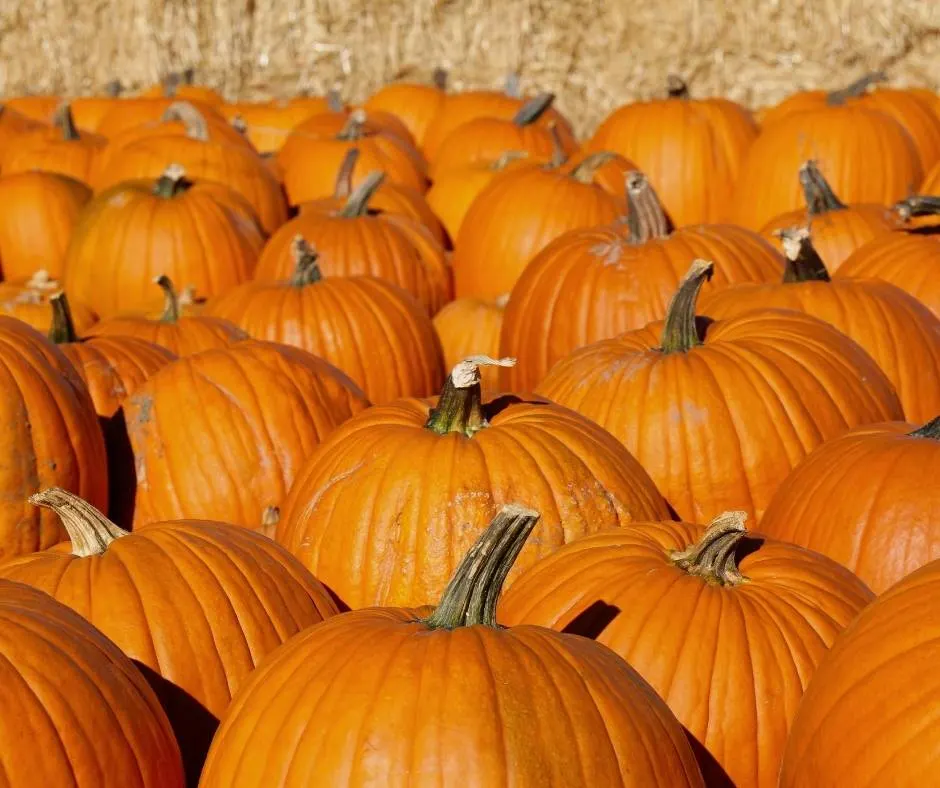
xmin=255 ymin=172 xmax=451 ymax=314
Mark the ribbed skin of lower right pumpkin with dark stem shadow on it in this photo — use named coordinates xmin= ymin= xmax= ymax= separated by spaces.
xmin=499 ymin=522 xmax=873 ymax=788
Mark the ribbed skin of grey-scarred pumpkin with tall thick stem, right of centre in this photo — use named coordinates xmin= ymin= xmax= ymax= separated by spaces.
xmin=500 ymin=225 xmax=783 ymax=391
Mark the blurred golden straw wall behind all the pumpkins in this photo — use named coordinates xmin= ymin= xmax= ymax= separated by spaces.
xmin=0 ymin=0 xmax=940 ymax=132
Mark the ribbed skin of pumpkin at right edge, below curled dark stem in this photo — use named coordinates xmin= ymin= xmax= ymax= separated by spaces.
xmin=839 ymin=234 xmax=940 ymax=318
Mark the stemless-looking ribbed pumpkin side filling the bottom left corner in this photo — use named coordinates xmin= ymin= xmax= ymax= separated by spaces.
xmin=0 ymin=580 xmax=185 ymax=788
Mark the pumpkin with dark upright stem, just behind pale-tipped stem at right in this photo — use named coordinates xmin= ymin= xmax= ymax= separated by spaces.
xmin=761 ymin=160 xmax=904 ymax=273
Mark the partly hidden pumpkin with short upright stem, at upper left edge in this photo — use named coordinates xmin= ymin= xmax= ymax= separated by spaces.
xmin=0 ymin=102 xmax=107 ymax=183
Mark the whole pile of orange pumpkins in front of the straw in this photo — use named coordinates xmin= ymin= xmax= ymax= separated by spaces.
xmin=0 ymin=70 xmax=940 ymax=788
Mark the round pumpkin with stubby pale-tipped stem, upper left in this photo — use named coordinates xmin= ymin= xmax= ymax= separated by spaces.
xmin=65 ymin=165 xmax=264 ymax=317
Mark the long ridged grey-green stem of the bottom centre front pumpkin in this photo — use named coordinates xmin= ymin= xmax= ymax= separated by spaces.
xmin=424 ymin=503 xmax=539 ymax=629
